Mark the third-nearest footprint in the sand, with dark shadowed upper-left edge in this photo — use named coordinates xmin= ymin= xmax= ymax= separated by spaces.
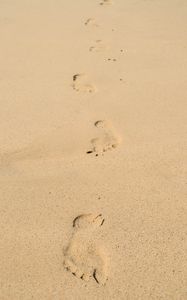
xmin=72 ymin=74 xmax=96 ymax=93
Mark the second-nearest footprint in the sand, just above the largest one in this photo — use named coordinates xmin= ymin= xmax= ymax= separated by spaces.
xmin=87 ymin=120 xmax=121 ymax=156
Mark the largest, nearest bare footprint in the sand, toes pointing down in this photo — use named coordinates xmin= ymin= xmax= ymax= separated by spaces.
xmin=64 ymin=214 xmax=108 ymax=285
